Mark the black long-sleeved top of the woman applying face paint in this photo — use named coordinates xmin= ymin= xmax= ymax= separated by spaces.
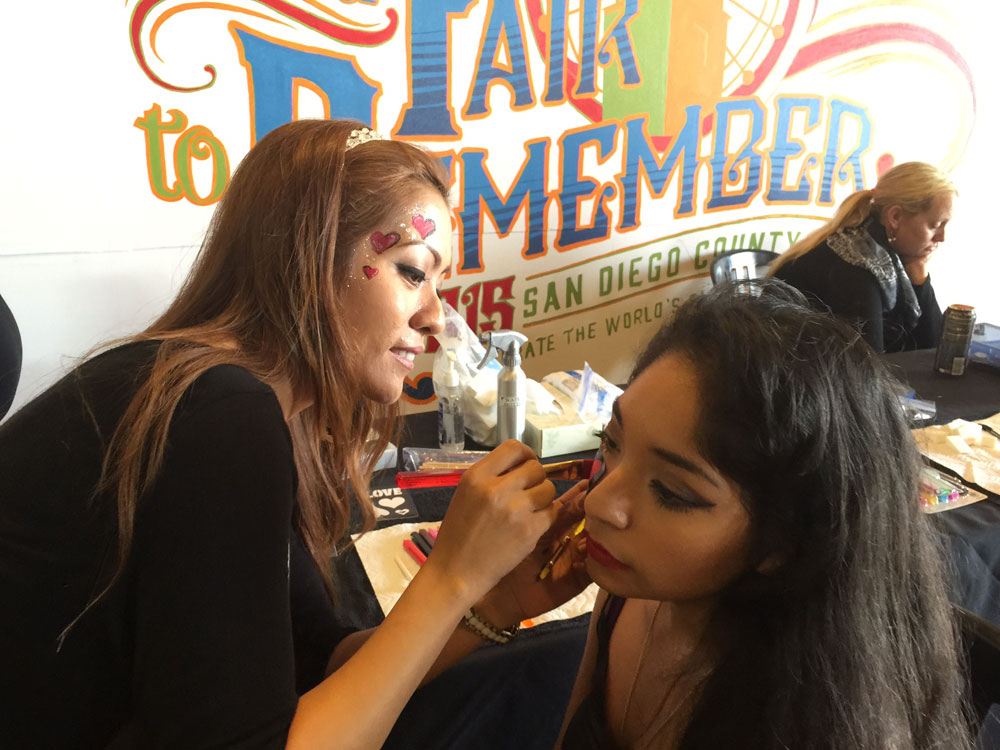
xmin=0 ymin=342 xmax=352 ymax=749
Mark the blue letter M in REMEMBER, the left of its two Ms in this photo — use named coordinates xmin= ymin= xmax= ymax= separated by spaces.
xmin=458 ymin=138 xmax=549 ymax=273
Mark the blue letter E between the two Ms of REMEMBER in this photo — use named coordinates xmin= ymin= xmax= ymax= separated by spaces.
xmin=556 ymin=123 xmax=618 ymax=248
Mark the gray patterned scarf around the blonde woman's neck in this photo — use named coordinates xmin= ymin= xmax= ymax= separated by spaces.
xmin=826 ymin=218 xmax=921 ymax=329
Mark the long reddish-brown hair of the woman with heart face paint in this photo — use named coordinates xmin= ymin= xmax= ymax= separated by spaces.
xmin=67 ymin=120 xmax=448 ymax=630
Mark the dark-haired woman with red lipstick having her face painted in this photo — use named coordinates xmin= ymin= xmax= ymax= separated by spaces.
xmin=560 ymin=281 xmax=970 ymax=750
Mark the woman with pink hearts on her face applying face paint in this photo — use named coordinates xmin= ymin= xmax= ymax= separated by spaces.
xmin=0 ymin=120 xmax=579 ymax=749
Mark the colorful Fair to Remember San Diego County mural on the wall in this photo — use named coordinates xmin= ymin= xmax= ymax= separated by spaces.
xmin=62 ymin=0 xmax=976 ymax=404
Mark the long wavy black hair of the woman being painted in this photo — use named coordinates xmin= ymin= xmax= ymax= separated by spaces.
xmin=631 ymin=281 xmax=970 ymax=750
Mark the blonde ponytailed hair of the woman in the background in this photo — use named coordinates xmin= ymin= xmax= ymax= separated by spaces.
xmin=767 ymin=161 xmax=957 ymax=276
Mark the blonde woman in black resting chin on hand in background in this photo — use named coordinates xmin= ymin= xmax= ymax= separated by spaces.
xmin=769 ymin=161 xmax=956 ymax=352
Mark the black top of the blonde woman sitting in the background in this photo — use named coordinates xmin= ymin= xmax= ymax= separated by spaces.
xmin=774 ymin=222 xmax=941 ymax=353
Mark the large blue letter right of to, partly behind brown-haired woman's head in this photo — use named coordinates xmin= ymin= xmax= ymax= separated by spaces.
xmin=234 ymin=27 xmax=378 ymax=145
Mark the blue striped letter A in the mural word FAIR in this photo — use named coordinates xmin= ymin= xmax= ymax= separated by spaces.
xmin=465 ymin=0 xmax=535 ymax=117
